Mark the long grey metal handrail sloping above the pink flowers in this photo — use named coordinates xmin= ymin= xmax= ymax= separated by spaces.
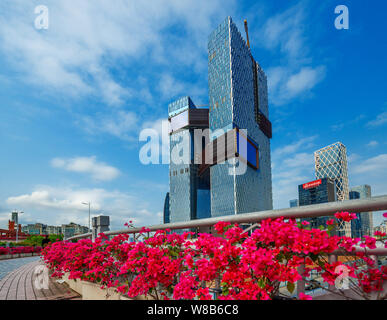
xmin=66 ymin=195 xmax=387 ymax=240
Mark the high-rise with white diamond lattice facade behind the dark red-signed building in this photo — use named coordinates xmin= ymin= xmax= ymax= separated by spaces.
xmin=314 ymin=142 xmax=351 ymax=237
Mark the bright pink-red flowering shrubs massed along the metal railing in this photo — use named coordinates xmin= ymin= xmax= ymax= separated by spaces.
xmin=42 ymin=212 xmax=387 ymax=300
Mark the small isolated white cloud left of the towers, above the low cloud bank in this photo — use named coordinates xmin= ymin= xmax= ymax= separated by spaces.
xmin=51 ymin=156 xmax=120 ymax=181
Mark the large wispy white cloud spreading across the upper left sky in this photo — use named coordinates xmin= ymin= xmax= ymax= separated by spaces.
xmin=0 ymin=0 xmax=234 ymax=105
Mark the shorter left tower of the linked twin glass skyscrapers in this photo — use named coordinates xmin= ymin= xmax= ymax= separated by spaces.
xmin=168 ymin=97 xmax=211 ymax=222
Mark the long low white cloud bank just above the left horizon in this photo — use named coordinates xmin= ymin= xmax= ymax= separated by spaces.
xmin=6 ymin=186 xmax=160 ymax=230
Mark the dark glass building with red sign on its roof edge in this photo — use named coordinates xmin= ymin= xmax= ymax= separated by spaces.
xmin=298 ymin=178 xmax=336 ymax=228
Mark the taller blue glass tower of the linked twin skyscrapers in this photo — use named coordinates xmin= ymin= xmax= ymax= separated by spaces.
xmin=208 ymin=17 xmax=273 ymax=217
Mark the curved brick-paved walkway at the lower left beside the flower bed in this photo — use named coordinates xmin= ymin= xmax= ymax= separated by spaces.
xmin=0 ymin=257 xmax=79 ymax=300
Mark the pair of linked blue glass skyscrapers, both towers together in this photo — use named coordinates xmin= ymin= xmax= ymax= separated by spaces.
xmin=164 ymin=17 xmax=273 ymax=223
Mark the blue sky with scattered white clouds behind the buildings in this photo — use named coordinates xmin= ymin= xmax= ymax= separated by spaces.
xmin=0 ymin=0 xmax=387 ymax=228
